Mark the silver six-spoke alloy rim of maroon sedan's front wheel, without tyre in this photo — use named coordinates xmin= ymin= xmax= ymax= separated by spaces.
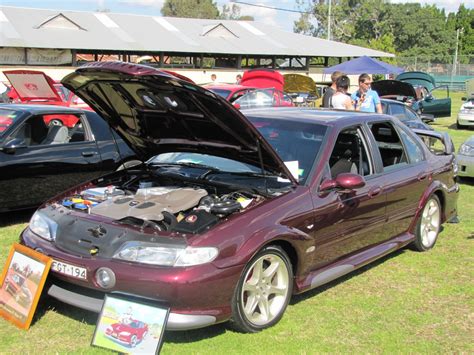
xmin=240 ymin=254 xmax=291 ymax=326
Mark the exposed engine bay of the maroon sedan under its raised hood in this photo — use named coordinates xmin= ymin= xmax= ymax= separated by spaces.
xmin=57 ymin=181 xmax=259 ymax=233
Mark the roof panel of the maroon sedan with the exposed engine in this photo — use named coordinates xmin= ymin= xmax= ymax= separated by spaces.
xmin=242 ymin=107 xmax=390 ymax=126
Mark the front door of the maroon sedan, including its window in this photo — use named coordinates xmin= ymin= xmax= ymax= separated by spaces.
xmin=314 ymin=126 xmax=386 ymax=268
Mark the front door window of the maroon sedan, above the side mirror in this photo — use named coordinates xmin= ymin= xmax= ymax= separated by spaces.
xmin=329 ymin=127 xmax=374 ymax=179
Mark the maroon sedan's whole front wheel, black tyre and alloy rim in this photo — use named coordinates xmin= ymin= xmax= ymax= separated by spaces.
xmin=230 ymin=245 xmax=293 ymax=333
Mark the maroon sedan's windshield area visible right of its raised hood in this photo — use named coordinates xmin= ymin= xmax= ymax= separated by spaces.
xmin=248 ymin=117 xmax=327 ymax=183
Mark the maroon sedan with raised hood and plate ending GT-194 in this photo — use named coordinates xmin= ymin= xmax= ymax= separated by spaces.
xmin=21 ymin=63 xmax=459 ymax=332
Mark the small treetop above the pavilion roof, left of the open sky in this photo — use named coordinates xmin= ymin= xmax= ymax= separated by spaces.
xmin=161 ymin=0 xmax=219 ymax=19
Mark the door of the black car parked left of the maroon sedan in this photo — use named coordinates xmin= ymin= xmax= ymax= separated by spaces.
xmin=0 ymin=115 xmax=103 ymax=210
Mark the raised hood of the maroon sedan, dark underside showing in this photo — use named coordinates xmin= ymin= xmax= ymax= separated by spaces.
xmin=62 ymin=62 xmax=295 ymax=182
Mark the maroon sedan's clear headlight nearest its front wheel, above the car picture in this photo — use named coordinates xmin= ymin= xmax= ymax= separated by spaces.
xmin=114 ymin=242 xmax=218 ymax=266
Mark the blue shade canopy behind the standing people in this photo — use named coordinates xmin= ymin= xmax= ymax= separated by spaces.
xmin=323 ymin=56 xmax=404 ymax=74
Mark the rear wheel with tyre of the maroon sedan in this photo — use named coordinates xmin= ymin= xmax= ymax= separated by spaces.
xmin=412 ymin=195 xmax=442 ymax=251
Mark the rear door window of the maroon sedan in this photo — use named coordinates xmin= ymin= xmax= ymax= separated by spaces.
xmin=369 ymin=122 xmax=408 ymax=171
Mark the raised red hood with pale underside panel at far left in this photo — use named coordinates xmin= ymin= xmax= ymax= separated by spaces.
xmin=3 ymin=70 xmax=62 ymax=102
